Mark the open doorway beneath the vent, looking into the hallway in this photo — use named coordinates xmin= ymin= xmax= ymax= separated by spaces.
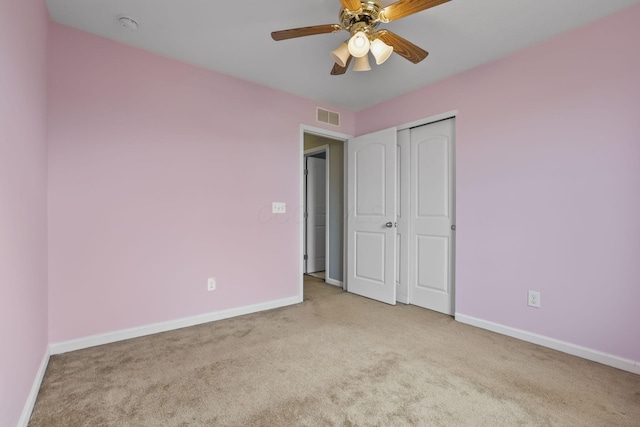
xmin=300 ymin=126 xmax=349 ymax=296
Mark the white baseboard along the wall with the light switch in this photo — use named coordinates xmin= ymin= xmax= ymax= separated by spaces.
xmin=49 ymin=296 xmax=302 ymax=355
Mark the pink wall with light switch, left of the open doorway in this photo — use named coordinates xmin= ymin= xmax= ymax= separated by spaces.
xmin=49 ymin=24 xmax=355 ymax=343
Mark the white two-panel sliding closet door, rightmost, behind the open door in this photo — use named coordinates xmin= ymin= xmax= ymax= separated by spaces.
xmin=409 ymin=119 xmax=455 ymax=315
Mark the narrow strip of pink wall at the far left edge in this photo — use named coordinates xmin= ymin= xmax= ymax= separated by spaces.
xmin=0 ymin=0 xmax=48 ymax=426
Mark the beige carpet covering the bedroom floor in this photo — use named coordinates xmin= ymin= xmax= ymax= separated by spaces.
xmin=29 ymin=277 xmax=640 ymax=427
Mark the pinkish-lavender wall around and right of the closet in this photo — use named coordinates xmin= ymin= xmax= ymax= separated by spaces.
xmin=356 ymin=6 xmax=640 ymax=361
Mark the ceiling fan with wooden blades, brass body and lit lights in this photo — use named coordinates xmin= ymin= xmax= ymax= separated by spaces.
xmin=271 ymin=0 xmax=450 ymax=76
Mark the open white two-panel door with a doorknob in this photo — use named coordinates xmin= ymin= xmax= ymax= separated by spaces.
xmin=347 ymin=128 xmax=397 ymax=304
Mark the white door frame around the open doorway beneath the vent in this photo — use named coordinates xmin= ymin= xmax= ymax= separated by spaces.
xmin=298 ymin=124 xmax=353 ymax=302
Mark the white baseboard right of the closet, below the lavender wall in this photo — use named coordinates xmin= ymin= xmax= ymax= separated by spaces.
xmin=455 ymin=313 xmax=640 ymax=375
